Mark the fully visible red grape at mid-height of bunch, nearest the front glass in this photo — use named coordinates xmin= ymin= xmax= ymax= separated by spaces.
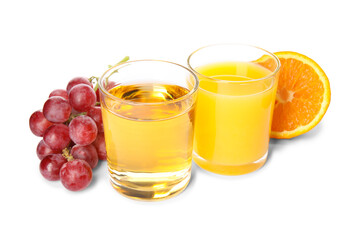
xmin=69 ymin=115 xmax=98 ymax=145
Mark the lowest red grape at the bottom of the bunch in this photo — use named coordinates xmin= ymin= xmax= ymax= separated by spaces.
xmin=60 ymin=159 xmax=92 ymax=191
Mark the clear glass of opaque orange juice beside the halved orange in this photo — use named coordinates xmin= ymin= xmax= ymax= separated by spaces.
xmin=188 ymin=44 xmax=280 ymax=175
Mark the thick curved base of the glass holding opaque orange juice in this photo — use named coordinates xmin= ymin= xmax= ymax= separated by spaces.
xmin=193 ymin=152 xmax=268 ymax=175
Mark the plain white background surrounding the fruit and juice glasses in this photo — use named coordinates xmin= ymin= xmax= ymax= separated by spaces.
xmin=0 ymin=0 xmax=360 ymax=239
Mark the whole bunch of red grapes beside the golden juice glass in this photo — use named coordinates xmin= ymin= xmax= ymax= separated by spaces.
xmin=29 ymin=77 xmax=106 ymax=191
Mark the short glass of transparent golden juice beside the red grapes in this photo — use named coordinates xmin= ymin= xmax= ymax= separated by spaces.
xmin=99 ymin=60 xmax=199 ymax=200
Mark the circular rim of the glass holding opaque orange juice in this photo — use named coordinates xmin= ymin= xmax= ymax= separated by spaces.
xmin=187 ymin=43 xmax=281 ymax=83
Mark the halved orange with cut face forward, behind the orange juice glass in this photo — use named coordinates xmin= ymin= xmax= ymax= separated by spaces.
xmin=257 ymin=52 xmax=331 ymax=138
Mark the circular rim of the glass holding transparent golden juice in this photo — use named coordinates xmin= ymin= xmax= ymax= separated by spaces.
xmin=99 ymin=59 xmax=199 ymax=106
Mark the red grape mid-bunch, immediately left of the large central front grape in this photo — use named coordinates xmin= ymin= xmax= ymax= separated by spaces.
xmin=44 ymin=124 xmax=70 ymax=151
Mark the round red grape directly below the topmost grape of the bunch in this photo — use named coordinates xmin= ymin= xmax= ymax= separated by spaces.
xmin=69 ymin=84 xmax=96 ymax=112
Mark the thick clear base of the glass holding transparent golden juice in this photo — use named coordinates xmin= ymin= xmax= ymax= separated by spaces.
xmin=108 ymin=167 xmax=191 ymax=201
